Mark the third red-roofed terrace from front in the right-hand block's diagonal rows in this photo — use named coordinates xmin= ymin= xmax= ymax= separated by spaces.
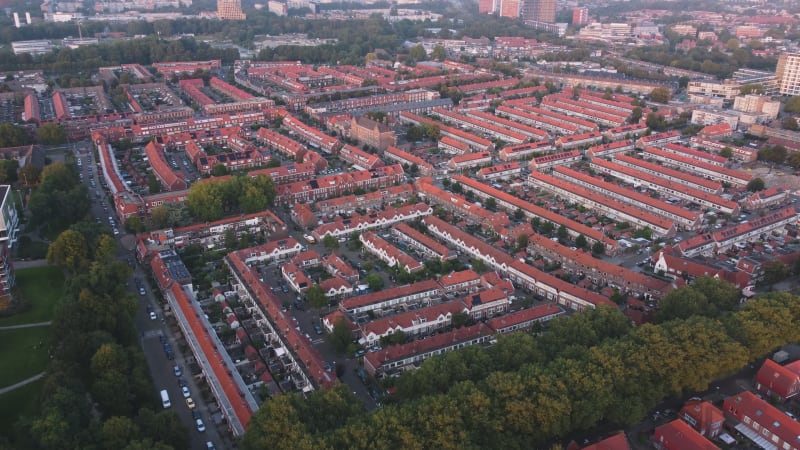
xmin=552 ymin=167 xmax=701 ymax=231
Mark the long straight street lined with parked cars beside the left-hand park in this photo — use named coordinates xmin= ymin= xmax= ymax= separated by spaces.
xmin=78 ymin=142 xmax=223 ymax=450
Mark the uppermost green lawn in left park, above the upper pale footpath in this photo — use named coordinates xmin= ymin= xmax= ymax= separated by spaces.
xmin=0 ymin=266 xmax=64 ymax=326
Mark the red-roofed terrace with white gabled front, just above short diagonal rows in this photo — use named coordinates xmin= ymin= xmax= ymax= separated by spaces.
xmin=312 ymin=202 xmax=433 ymax=240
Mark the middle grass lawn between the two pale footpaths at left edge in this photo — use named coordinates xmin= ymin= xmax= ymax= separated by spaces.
xmin=0 ymin=327 xmax=50 ymax=387
